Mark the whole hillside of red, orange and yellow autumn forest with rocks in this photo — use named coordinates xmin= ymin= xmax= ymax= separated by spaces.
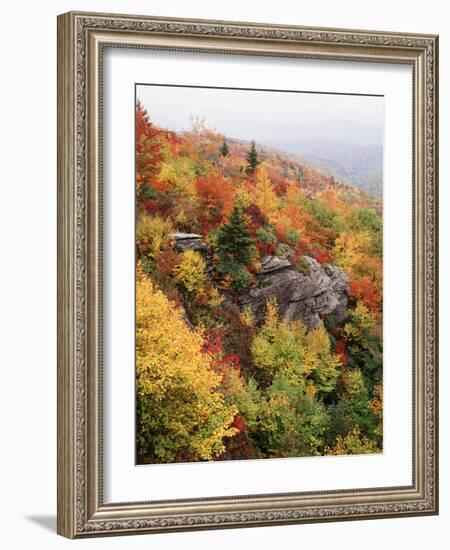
xmin=136 ymin=102 xmax=383 ymax=464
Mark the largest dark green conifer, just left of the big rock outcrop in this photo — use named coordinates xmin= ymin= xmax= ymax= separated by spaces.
xmin=218 ymin=207 xmax=254 ymax=265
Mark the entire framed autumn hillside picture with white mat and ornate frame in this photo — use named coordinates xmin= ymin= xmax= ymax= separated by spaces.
xmin=58 ymin=12 xmax=438 ymax=538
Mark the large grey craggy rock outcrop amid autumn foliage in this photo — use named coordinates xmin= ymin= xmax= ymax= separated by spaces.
xmin=240 ymin=256 xmax=348 ymax=330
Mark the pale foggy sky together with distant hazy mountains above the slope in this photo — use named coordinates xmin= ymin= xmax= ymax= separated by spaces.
xmin=137 ymin=85 xmax=384 ymax=196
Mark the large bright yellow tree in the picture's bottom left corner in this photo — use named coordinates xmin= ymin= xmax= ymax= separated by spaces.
xmin=136 ymin=271 xmax=237 ymax=463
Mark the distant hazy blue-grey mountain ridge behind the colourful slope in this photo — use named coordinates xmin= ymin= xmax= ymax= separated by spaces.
xmin=266 ymin=139 xmax=383 ymax=197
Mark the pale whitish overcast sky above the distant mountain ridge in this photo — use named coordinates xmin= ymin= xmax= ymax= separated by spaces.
xmin=136 ymin=85 xmax=384 ymax=146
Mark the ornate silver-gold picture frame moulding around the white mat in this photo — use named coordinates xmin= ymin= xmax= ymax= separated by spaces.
xmin=58 ymin=12 xmax=438 ymax=538
